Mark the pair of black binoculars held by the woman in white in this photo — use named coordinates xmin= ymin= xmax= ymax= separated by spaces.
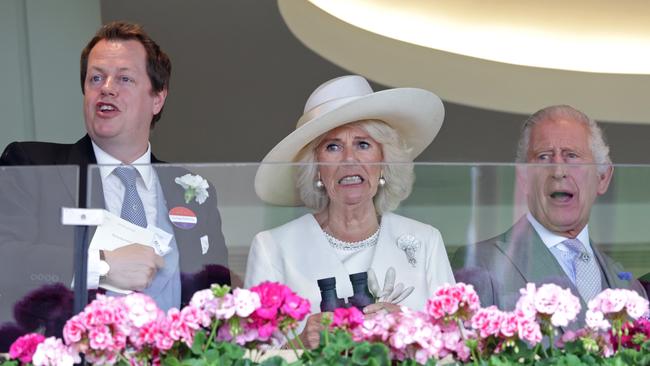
xmin=316 ymin=272 xmax=375 ymax=312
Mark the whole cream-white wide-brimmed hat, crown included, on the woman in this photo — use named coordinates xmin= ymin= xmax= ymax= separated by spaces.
xmin=255 ymin=75 xmax=445 ymax=206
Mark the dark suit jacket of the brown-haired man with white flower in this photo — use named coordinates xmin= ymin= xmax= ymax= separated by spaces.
xmin=0 ymin=135 xmax=230 ymax=312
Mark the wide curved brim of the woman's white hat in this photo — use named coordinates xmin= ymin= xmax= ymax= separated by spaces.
xmin=255 ymin=88 xmax=445 ymax=206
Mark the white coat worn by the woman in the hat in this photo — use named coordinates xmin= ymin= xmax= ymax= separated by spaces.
xmin=245 ymin=213 xmax=455 ymax=313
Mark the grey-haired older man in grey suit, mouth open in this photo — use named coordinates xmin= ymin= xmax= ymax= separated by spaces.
xmin=452 ymin=105 xmax=646 ymax=311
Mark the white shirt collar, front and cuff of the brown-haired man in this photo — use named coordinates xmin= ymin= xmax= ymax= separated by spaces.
xmin=87 ymin=141 xmax=158 ymax=289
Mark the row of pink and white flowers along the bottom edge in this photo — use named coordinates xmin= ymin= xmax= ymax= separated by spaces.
xmin=0 ymin=282 xmax=650 ymax=366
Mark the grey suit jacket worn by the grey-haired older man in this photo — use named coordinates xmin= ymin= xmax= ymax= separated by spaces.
xmin=451 ymin=216 xmax=647 ymax=320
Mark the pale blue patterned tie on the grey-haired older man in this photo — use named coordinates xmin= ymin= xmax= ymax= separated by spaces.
xmin=562 ymin=239 xmax=602 ymax=302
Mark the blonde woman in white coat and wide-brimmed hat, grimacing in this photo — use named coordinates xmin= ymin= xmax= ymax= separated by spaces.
xmin=245 ymin=75 xmax=454 ymax=346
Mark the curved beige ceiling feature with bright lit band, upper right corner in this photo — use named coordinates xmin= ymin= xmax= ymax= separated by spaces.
xmin=278 ymin=0 xmax=650 ymax=123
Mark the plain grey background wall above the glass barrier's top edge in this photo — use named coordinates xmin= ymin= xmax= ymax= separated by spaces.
xmin=0 ymin=0 xmax=650 ymax=163
